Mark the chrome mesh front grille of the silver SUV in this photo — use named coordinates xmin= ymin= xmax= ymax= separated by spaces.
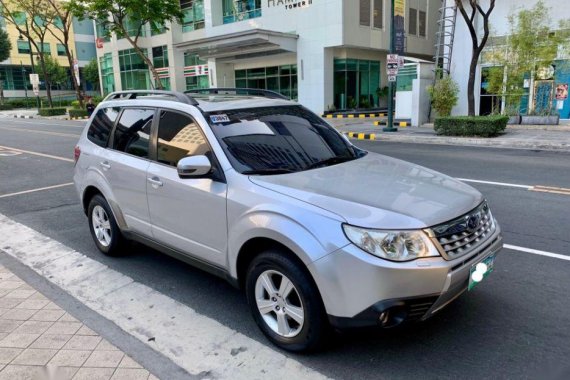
xmin=432 ymin=202 xmax=495 ymax=260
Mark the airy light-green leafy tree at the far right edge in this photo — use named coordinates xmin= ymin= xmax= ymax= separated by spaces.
xmin=488 ymin=0 xmax=570 ymax=114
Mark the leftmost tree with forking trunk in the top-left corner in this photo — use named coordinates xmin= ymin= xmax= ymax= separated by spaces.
xmin=0 ymin=0 xmax=55 ymax=107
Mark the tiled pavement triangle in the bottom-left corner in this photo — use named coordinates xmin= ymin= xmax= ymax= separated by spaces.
xmin=0 ymin=266 xmax=157 ymax=380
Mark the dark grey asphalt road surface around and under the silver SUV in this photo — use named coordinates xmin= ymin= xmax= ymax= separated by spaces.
xmin=0 ymin=119 xmax=570 ymax=379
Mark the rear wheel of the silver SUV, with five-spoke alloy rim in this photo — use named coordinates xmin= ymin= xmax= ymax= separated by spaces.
xmin=87 ymin=194 xmax=123 ymax=256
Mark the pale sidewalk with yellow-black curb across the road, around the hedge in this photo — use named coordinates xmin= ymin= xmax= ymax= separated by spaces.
xmin=327 ymin=119 xmax=570 ymax=151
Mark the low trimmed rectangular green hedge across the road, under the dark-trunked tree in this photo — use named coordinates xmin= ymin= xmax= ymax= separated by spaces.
xmin=434 ymin=115 xmax=509 ymax=137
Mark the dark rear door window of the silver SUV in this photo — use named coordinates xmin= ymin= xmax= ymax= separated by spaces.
xmin=113 ymin=108 xmax=154 ymax=158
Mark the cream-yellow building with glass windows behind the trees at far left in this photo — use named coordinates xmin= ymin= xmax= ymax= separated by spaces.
xmin=0 ymin=14 xmax=96 ymax=98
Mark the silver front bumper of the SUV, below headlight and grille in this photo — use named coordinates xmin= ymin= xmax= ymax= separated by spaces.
xmin=309 ymin=225 xmax=503 ymax=328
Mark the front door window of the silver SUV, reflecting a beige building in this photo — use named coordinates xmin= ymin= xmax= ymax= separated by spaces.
xmin=157 ymin=111 xmax=212 ymax=166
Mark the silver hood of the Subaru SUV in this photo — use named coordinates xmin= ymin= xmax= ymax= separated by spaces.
xmin=250 ymin=153 xmax=483 ymax=229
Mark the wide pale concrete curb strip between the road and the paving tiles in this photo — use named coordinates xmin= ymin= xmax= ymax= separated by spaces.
xmin=0 ymin=214 xmax=325 ymax=380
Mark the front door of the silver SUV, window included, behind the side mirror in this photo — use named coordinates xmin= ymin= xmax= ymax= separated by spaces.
xmin=147 ymin=110 xmax=227 ymax=267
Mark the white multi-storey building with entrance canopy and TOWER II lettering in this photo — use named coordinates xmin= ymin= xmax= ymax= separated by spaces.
xmin=97 ymin=0 xmax=441 ymax=112
